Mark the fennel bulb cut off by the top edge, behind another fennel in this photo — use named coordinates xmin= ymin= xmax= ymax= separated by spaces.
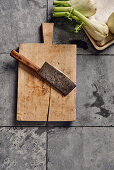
xmin=53 ymin=0 xmax=97 ymax=17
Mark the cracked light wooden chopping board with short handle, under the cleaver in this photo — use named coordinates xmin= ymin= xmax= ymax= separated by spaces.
xmin=17 ymin=23 xmax=76 ymax=121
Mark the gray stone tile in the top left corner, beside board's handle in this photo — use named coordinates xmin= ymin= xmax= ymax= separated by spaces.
xmin=0 ymin=0 xmax=47 ymax=53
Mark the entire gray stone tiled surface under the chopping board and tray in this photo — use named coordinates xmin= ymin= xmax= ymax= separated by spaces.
xmin=0 ymin=0 xmax=114 ymax=170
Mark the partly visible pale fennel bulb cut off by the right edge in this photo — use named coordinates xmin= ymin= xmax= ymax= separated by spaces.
xmin=107 ymin=12 xmax=114 ymax=34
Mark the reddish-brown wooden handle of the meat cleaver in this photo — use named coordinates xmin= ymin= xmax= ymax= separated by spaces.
xmin=10 ymin=50 xmax=40 ymax=72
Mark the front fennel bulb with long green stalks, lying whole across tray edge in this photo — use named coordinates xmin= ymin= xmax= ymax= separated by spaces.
xmin=53 ymin=7 xmax=109 ymax=41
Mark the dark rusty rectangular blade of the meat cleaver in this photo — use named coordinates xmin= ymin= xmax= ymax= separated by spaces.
xmin=38 ymin=62 xmax=76 ymax=96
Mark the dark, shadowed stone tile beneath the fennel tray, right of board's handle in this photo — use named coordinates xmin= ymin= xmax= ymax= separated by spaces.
xmin=48 ymin=0 xmax=114 ymax=54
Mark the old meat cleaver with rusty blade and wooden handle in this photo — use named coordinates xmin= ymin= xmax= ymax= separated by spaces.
xmin=10 ymin=50 xmax=76 ymax=96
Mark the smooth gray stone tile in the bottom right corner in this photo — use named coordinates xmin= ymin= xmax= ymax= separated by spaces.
xmin=48 ymin=127 xmax=114 ymax=170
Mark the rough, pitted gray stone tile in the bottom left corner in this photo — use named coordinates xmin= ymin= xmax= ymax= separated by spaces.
xmin=0 ymin=127 xmax=46 ymax=170
